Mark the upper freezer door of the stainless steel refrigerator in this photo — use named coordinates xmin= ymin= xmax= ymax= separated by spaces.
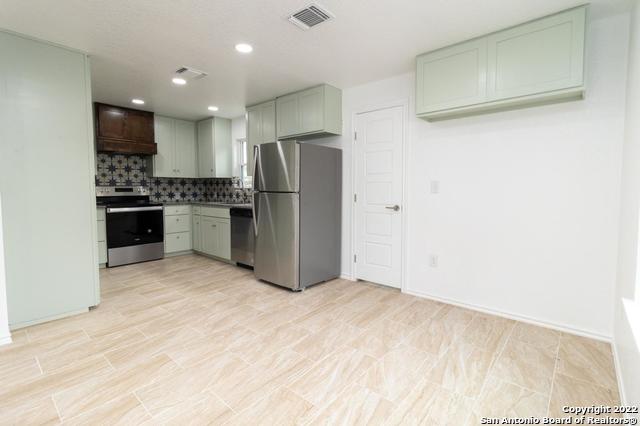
xmin=253 ymin=141 xmax=300 ymax=192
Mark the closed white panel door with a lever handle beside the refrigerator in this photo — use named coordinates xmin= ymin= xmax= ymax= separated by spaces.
xmin=355 ymin=107 xmax=404 ymax=288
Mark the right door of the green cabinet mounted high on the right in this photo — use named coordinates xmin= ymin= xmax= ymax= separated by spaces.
xmin=488 ymin=8 xmax=586 ymax=100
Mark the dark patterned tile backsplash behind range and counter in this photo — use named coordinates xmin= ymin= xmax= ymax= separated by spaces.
xmin=96 ymin=153 xmax=251 ymax=203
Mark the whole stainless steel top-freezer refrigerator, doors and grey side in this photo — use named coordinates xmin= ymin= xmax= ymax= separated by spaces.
xmin=253 ymin=141 xmax=342 ymax=291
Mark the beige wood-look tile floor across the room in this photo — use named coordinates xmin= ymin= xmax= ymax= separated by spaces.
xmin=0 ymin=255 xmax=618 ymax=425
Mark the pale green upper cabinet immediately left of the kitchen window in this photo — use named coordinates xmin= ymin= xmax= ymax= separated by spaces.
xmin=198 ymin=117 xmax=233 ymax=178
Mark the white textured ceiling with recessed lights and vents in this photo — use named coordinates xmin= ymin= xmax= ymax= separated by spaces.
xmin=0 ymin=0 xmax=628 ymax=119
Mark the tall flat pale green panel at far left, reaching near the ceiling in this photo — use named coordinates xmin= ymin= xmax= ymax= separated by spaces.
xmin=0 ymin=31 xmax=100 ymax=329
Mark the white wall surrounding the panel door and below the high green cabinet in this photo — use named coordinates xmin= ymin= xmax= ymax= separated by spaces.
xmin=316 ymin=10 xmax=629 ymax=337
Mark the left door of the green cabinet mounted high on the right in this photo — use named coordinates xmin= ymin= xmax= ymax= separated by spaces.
xmin=416 ymin=38 xmax=487 ymax=115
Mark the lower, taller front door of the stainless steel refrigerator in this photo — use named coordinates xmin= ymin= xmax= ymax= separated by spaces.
xmin=254 ymin=192 xmax=300 ymax=290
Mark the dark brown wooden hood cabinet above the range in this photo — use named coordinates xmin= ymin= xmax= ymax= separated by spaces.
xmin=95 ymin=102 xmax=158 ymax=155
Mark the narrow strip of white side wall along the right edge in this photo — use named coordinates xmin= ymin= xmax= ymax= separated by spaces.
xmin=614 ymin=2 xmax=640 ymax=412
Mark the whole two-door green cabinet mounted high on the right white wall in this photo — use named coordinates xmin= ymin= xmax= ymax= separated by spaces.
xmin=416 ymin=6 xmax=587 ymax=120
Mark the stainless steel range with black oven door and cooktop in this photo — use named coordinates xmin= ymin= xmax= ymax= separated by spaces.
xmin=96 ymin=186 xmax=164 ymax=267
